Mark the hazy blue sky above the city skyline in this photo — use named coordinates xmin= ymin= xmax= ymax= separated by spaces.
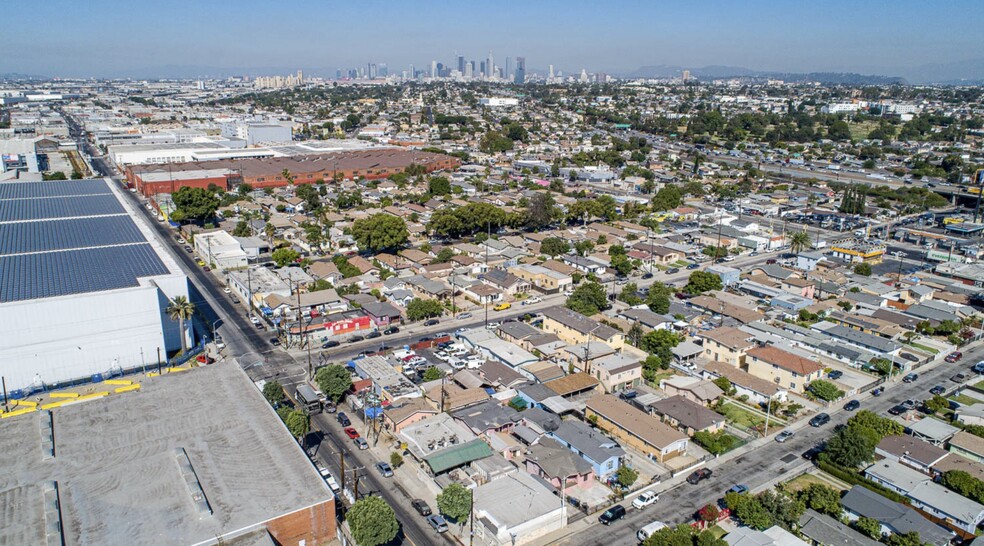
xmin=0 ymin=0 xmax=984 ymax=79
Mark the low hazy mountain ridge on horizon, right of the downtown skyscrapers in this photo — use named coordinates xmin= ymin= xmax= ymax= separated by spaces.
xmin=624 ymin=65 xmax=906 ymax=85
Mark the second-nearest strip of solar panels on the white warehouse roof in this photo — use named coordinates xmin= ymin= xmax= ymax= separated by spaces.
xmin=0 ymin=216 xmax=146 ymax=256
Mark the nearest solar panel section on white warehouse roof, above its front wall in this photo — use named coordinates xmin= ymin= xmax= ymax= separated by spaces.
xmin=0 ymin=243 xmax=168 ymax=303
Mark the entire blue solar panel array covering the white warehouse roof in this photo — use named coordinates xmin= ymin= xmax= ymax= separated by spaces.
xmin=0 ymin=180 xmax=170 ymax=303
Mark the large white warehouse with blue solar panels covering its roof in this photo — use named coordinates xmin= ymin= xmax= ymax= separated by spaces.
xmin=0 ymin=179 xmax=192 ymax=390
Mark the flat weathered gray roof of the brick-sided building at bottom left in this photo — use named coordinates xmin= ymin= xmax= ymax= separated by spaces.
xmin=0 ymin=363 xmax=332 ymax=545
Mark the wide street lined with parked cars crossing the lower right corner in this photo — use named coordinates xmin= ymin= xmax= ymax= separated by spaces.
xmin=560 ymin=342 xmax=984 ymax=546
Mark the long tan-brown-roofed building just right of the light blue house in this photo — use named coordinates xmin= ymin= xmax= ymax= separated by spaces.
xmin=584 ymin=394 xmax=688 ymax=462
